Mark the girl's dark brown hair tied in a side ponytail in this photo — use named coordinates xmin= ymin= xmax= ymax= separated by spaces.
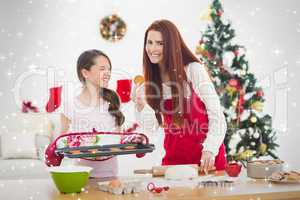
xmin=77 ymin=49 xmax=125 ymax=126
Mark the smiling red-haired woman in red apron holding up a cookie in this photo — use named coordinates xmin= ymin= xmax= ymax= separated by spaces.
xmin=133 ymin=20 xmax=226 ymax=172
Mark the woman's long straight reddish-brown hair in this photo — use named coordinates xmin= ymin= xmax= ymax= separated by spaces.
xmin=143 ymin=20 xmax=200 ymax=126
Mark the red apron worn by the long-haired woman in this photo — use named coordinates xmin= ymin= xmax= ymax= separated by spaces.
xmin=162 ymin=84 xmax=227 ymax=170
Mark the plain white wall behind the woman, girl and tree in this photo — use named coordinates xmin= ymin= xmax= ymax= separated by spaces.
xmin=0 ymin=0 xmax=300 ymax=173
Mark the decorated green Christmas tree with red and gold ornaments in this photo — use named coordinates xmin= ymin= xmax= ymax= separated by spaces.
xmin=196 ymin=0 xmax=279 ymax=160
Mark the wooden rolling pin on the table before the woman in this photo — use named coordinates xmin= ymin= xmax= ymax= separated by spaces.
xmin=133 ymin=164 xmax=215 ymax=177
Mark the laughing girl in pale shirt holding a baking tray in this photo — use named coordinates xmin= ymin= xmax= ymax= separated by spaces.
xmin=61 ymin=50 xmax=125 ymax=178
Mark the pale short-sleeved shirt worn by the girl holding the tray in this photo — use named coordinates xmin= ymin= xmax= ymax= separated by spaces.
xmin=63 ymin=97 xmax=120 ymax=178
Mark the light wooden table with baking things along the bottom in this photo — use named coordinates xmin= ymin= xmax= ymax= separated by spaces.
xmin=0 ymin=174 xmax=300 ymax=200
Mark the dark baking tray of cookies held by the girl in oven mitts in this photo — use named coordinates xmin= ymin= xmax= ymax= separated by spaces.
xmin=55 ymin=144 xmax=155 ymax=158
